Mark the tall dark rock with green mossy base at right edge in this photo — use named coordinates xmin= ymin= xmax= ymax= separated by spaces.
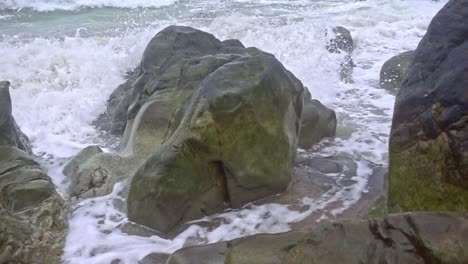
xmin=389 ymin=0 xmax=468 ymax=212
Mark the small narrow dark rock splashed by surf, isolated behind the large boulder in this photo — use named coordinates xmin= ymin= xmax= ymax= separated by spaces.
xmin=325 ymin=26 xmax=355 ymax=83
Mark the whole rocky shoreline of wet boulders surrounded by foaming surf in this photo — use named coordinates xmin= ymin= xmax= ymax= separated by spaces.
xmin=0 ymin=0 xmax=468 ymax=264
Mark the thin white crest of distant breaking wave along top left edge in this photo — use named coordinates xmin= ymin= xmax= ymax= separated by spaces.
xmin=0 ymin=0 xmax=177 ymax=12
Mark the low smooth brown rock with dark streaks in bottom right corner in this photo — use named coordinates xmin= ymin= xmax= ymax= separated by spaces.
xmin=285 ymin=213 xmax=468 ymax=264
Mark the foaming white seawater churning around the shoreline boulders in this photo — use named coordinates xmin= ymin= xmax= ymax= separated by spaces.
xmin=0 ymin=0 xmax=444 ymax=263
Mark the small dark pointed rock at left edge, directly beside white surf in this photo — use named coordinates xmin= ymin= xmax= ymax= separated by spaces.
xmin=0 ymin=81 xmax=32 ymax=153
